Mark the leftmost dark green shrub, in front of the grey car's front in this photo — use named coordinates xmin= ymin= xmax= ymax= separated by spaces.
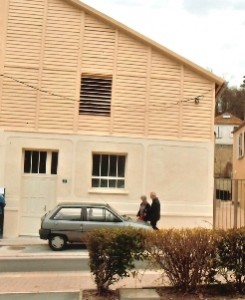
xmin=87 ymin=228 xmax=144 ymax=295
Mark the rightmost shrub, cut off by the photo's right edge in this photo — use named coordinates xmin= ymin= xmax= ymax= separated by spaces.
xmin=217 ymin=228 xmax=245 ymax=292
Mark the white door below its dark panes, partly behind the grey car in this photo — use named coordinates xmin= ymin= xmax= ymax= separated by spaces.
xmin=20 ymin=174 xmax=57 ymax=236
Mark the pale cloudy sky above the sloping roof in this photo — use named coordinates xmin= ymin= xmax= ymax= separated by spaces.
xmin=82 ymin=0 xmax=245 ymax=88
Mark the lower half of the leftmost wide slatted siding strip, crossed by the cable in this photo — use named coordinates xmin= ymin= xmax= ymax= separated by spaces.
xmin=0 ymin=68 xmax=38 ymax=129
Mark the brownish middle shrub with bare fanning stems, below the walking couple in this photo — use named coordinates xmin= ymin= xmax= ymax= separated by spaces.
xmin=146 ymin=228 xmax=217 ymax=292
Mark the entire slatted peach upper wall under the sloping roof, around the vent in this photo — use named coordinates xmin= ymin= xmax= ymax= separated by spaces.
xmin=0 ymin=0 xmax=217 ymax=140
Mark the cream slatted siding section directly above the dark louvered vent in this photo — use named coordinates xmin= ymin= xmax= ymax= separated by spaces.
xmin=82 ymin=14 xmax=115 ymax=71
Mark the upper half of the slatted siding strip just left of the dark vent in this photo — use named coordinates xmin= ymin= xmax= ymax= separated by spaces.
xmin=43 ymin=0 xmax=81 ymax=72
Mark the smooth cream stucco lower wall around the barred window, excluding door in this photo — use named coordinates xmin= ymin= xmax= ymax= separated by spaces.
xmin=1 ymin=132 xmax=213 ymax=235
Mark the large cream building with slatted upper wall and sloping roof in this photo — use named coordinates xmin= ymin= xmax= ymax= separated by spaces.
xmin=0 ymin=0 xmax=224 ymax=237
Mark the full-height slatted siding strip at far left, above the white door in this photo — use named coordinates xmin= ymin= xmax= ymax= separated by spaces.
xmin=0 ymin=0 xmax=44 ymax=130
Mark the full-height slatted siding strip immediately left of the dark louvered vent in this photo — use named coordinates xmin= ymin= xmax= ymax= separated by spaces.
xmin=37 ymin=0 xmax=81 ymax=132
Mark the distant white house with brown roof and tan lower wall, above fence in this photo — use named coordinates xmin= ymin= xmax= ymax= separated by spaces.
xmin=214 ymin=112 xmax=243 ymax=178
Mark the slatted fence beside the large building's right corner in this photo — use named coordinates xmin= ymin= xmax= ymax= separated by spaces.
xmin=213 ymin=178 xmax=245 ymax=229
